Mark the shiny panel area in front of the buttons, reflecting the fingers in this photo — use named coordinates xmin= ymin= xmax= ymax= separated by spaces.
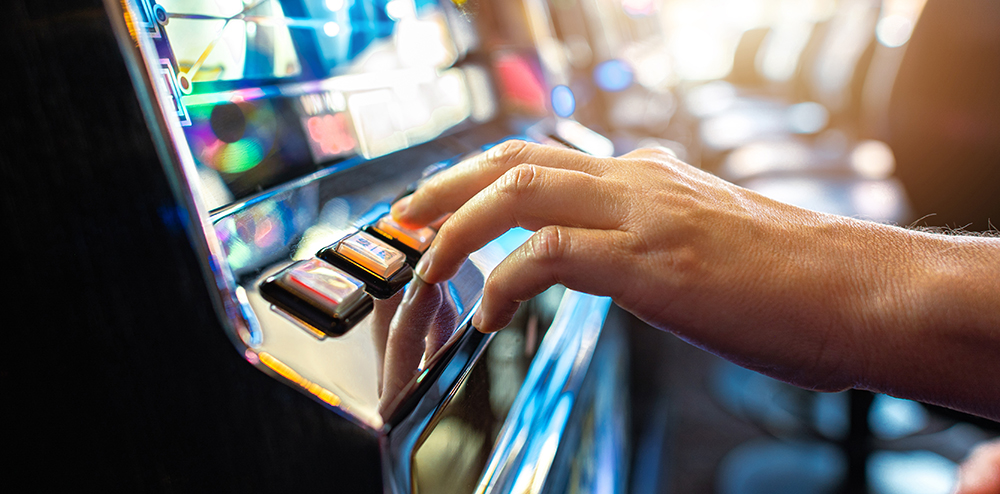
xmin=242 ymin=239 xmax=483 ymax=428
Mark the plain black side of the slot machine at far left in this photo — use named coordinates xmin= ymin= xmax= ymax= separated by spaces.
xmin=0 ymin=0 xmax=381 ymax=493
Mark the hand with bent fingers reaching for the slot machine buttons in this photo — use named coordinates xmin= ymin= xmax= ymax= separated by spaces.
xmin=392 ymin=141 xmax=895 ymax=390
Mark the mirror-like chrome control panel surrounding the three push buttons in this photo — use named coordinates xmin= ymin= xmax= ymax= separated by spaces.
xmin=207 ymin=132 xmax=527 ymax=430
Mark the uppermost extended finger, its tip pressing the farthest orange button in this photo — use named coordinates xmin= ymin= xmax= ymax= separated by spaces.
xmin=392 ymin=140 xmax=606 ymax=227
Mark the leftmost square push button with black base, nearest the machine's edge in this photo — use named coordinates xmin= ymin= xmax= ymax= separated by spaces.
xmin=260 ymin=259 xmax=372 ymax=336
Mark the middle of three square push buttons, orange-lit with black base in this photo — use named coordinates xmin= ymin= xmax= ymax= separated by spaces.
xmin=316 ymin=232 xmax=413 ymax=298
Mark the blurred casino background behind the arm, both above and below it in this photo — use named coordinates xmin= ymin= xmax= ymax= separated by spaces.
xmin=524 ymin=0 xmax=1000 ymax=494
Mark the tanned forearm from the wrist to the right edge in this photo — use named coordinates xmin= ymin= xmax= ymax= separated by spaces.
xmin=855 ymin=226 xmax=1000 ymax=419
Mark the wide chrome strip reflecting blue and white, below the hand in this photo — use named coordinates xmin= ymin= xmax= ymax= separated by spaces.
xmin=475 ymin=291 xmax=611 ymax=494
